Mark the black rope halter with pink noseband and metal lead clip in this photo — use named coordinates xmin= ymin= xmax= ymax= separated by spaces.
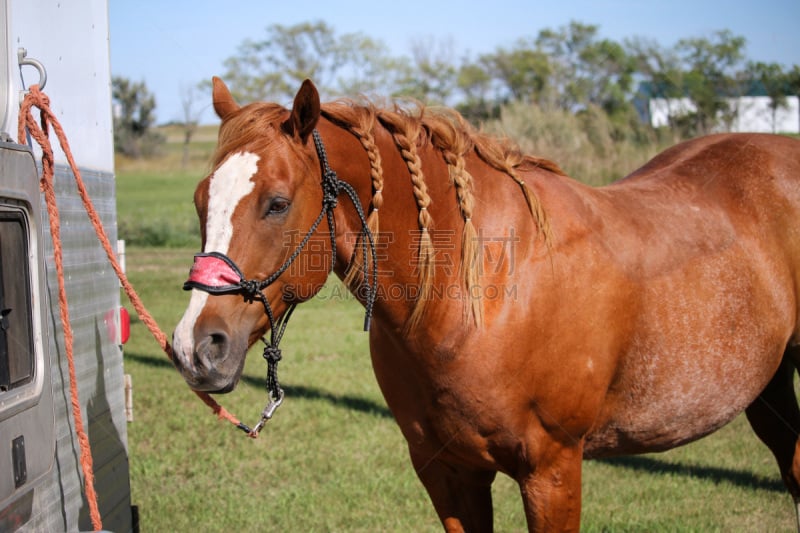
xmin=183 ymin=130 xmax=378 ymax=437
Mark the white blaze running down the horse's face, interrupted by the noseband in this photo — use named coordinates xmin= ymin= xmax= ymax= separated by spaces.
xmin=173 ymin=152 xmax=259 ymax=368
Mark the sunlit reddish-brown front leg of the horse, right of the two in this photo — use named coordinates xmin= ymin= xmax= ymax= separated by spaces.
xmin=517 ymin=442 xmax=583 ymax=532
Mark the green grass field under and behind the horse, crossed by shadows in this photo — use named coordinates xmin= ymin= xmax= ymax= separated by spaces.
xmin=117 ymin=127 xmax=794 ymax=532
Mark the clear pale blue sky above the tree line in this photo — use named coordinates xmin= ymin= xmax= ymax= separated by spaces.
xmin=109 ymin=0 xmax=800 ymax=122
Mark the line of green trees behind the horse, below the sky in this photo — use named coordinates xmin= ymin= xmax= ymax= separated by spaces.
xmin=113 ymin=21 xmax=800 ymax=160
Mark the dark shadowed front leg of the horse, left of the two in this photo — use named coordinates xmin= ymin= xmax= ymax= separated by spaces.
xmin=411 ymin=450 xmax=496 ymax=532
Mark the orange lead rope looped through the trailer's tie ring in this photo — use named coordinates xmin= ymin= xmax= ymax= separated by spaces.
xmin=17 ymin=85 xmax=239 ymax=531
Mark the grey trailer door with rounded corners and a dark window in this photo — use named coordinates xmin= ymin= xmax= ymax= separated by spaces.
xmin=0 ymin=142 xmax=55 ymax=531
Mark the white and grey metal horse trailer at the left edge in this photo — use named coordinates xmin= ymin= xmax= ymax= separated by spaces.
xmin=0 ymin=0 xmax=137 ymax=532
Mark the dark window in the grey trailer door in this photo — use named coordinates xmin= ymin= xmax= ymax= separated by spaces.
xmin=0 ymin=211 xmax=34 ymax=392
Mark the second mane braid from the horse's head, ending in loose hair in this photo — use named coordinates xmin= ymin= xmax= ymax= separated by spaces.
xmin=378 ymin=110 xmax=434 ymax=333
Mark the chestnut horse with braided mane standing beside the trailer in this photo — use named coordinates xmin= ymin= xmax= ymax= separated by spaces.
xmin=174 ymin=78 xmax=800 ymax=531
